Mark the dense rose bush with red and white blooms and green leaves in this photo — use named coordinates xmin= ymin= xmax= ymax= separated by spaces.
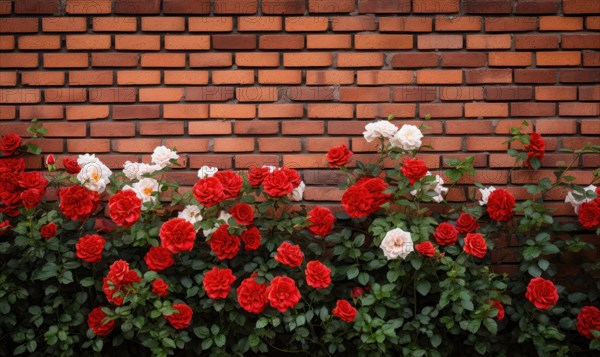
xmin=0 ymin=120 xmax=600 ymax=356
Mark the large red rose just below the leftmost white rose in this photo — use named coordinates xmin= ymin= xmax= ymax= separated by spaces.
xmin=58 ymin=186 xmax=100 ymax=221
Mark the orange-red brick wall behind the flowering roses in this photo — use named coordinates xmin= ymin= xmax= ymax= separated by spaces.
xmin=0 ymin=0 xmax=600 ymax=212
